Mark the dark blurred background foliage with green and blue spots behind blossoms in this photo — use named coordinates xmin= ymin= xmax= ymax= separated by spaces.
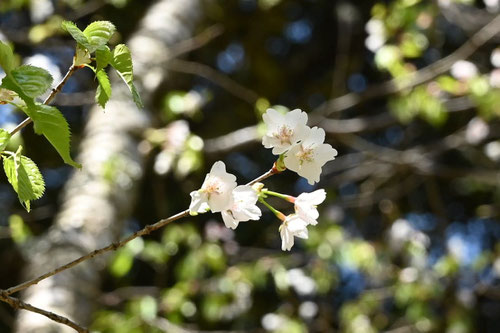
xmin=0 ymin=0 xmax=500 ymax=333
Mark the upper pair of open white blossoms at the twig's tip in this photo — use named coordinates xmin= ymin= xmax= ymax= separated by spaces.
xmin=262 ymin=109 xmax=337 ymax=185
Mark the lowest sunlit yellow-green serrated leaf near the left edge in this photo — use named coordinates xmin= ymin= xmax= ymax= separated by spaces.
xmin=3 ymin=147 xmax=45 ymax=212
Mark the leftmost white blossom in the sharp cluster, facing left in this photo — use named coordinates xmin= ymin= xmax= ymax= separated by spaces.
xmin=189 ymin=161 xmax=236 ymax=214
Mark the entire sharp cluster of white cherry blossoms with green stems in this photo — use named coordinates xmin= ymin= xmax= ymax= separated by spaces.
xmin=189 ymin=109 xmax=337 ymax=251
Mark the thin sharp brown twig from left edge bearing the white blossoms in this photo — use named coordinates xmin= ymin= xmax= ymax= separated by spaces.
xmin=0 ymin=167 xmax=279 ymax=295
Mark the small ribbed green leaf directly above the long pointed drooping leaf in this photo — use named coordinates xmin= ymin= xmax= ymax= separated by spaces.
xmin=11 ymin=65 xmax=53 ymax=98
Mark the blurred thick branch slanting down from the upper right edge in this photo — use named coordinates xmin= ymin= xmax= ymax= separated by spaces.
xmin=317 ymin=15 xmax=500 ymax=116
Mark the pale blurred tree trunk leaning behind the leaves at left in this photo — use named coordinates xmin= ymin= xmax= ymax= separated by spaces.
xmin=15 ymin=0 xmax=201 ymax=333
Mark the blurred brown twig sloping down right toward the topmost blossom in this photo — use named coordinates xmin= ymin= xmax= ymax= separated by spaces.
xmin=167 ymin=59 xmax=259 ymax=106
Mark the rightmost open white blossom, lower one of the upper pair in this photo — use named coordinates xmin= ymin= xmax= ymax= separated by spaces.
xmin=284 ymin=127 xmax=337 ymax=185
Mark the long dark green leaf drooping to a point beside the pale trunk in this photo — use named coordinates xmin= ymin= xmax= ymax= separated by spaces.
xmin=26 ymin=104 xmax=82 ymax=168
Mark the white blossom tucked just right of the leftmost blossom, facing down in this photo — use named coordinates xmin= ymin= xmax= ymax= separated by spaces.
xmin=221 ymin=185 xmax=262 ymax=229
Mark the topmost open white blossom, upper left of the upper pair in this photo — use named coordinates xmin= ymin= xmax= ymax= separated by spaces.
xmin=262 ymin=109 xmax=309 ymax=155
